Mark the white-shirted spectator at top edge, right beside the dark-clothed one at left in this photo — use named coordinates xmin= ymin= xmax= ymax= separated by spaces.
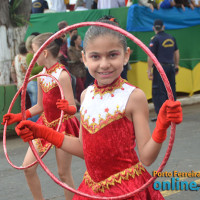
xmin=47 ymin=0 xmax=67 ymax=12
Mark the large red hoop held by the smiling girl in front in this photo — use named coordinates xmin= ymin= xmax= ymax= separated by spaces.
xmin=19 ymin=22 xmax=176 ymax=200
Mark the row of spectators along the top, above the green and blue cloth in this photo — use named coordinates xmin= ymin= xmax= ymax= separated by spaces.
xmin=31 ymin=0 xmax=200 ymax=14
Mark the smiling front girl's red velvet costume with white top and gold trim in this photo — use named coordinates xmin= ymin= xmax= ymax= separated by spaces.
xmin=73 ymin=77 xmax=164 ymax=200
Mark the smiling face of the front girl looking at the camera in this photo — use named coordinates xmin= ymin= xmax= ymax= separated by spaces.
xmin=82 ymin=34 xmax=130 ymax=86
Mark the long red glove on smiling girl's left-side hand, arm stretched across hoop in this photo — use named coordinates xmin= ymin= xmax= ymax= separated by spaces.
xmin=15 ymin=120 xmax=64 ymax=148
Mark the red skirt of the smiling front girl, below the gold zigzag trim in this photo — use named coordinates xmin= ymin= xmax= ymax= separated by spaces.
xmin=73 ymin=163 xmax=164 ymax=200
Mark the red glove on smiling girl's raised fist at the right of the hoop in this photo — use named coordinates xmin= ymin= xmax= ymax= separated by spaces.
xmin=152 ymin=100 xmax=183 ymax=143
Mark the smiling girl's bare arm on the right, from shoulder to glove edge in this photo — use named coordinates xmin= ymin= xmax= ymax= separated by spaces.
xmin=126 ymin=89 xmax=162 ymax=166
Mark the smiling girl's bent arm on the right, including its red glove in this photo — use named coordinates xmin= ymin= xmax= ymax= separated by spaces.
xmin=126 ymin=89 xmax=183 ymax=166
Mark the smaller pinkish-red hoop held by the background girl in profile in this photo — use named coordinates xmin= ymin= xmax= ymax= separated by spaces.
xmin=3 ymin=74 xmax=64 ymax=170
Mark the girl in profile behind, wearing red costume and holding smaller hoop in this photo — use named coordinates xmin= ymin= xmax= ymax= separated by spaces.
xmin=3 ymin=33 xmax=79 ymax=200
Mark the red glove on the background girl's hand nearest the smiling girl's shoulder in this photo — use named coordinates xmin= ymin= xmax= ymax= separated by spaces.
xmin=56 ymin=99 xmax=76 ymax=115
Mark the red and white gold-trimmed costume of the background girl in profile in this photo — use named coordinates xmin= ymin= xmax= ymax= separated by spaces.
xmin=35 ymin=63 xmax=79 ymax=152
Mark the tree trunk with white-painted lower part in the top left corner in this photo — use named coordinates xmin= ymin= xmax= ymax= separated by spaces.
xmin=0 ymin=0 xmax=32 ymax=85
